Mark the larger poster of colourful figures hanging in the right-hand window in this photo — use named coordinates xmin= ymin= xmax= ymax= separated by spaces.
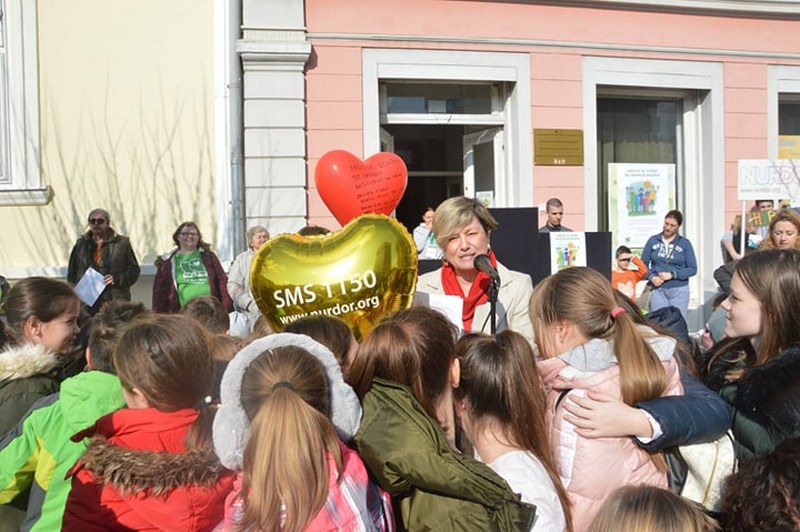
xmin=608 ymin=163 xmax=675 ymax=253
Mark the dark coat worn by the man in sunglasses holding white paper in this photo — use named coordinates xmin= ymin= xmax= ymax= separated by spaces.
xmin=67 ymin=229 xmax=139 ymax=312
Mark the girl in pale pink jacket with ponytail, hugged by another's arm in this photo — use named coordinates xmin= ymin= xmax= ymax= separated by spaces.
xmin=530 ymin=267 xmax=683 ymax=531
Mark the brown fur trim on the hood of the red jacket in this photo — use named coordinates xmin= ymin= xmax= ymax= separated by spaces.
xmin=80 ymin=436 xmax=224 ymax=496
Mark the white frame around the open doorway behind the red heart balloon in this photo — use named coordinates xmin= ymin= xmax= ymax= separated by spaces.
xmin=361 ymin=48 xmax=533 ymax=207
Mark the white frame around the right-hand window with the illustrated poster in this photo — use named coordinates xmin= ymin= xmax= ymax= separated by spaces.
xmin=583 ymin=57 xmax=725 ymax=328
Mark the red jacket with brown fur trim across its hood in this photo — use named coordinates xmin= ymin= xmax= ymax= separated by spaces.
xmin=62 ymin=408 xmax=234 ymax=532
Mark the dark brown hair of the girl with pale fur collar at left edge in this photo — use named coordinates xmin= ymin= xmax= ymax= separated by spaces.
xmin=4 ymin=277 xmax=79 ymax=343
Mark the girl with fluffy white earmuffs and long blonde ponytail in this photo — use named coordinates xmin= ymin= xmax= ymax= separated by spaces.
xmin=214 ymin=333 xmax=393 ymax=532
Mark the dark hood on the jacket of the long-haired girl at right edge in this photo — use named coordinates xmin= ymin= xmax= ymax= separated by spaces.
xmin=733 ymin=344 xmax=800 ymax=432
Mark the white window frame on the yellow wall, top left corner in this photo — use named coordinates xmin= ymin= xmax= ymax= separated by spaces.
xmin=0 ymin=0 xmax=44 ymax=205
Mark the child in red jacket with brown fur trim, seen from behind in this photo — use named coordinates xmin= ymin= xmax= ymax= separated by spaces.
xmin=62 ymin=315 xmax=233 ymax=532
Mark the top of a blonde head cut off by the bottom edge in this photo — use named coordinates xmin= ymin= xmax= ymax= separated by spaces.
xmin=589 ymin=486 xmax=719 ymax=532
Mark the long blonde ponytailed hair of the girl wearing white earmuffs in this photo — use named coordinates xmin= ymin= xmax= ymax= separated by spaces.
xmin=238 ymin=346 xmax=342 ymax=532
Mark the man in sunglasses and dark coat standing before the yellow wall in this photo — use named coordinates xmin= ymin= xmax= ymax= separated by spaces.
xmin=67 ymin=209 xmax=139 ymax=315
